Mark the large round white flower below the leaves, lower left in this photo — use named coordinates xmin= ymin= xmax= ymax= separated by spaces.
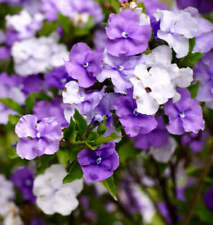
xmin=33 ymin=164 xmax=83 ymax=216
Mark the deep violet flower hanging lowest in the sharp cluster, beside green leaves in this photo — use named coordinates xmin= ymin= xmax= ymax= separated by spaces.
xmin=78 ymin=142 xmax=119 ymax=182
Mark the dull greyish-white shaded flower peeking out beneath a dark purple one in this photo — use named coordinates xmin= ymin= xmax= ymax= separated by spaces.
xmin=150 ymin=137 xmax=177 ymax=163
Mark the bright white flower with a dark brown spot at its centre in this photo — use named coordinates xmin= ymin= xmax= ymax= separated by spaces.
xmin=130 ymin=64 xmax=176 ymax=115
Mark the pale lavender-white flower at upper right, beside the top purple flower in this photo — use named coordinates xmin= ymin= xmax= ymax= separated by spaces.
xmin=155 ymin=10 xmax=198 ymax=58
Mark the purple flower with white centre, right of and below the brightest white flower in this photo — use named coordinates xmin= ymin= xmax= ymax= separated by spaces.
xmin=164 ymin=88 xmax=204 ymax=135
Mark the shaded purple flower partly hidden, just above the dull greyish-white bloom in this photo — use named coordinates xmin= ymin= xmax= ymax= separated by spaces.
xmin=134 ymin=117 xmax=169 ymax=150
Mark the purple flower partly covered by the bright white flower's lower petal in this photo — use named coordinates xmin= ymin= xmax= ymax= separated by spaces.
xmin=114 ymin=92 xmax=157 ymax=137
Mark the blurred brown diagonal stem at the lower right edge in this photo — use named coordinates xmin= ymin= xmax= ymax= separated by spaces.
xmin=182 ymin=140 xmax=213 ymax=225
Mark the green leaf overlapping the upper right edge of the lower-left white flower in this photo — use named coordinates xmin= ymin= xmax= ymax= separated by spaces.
xmin=63 ymin=162 xmax=83 ymax=184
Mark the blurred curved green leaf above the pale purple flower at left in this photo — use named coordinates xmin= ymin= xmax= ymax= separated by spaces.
xmin=25 ymin=92 xmax=52 ymax=113
